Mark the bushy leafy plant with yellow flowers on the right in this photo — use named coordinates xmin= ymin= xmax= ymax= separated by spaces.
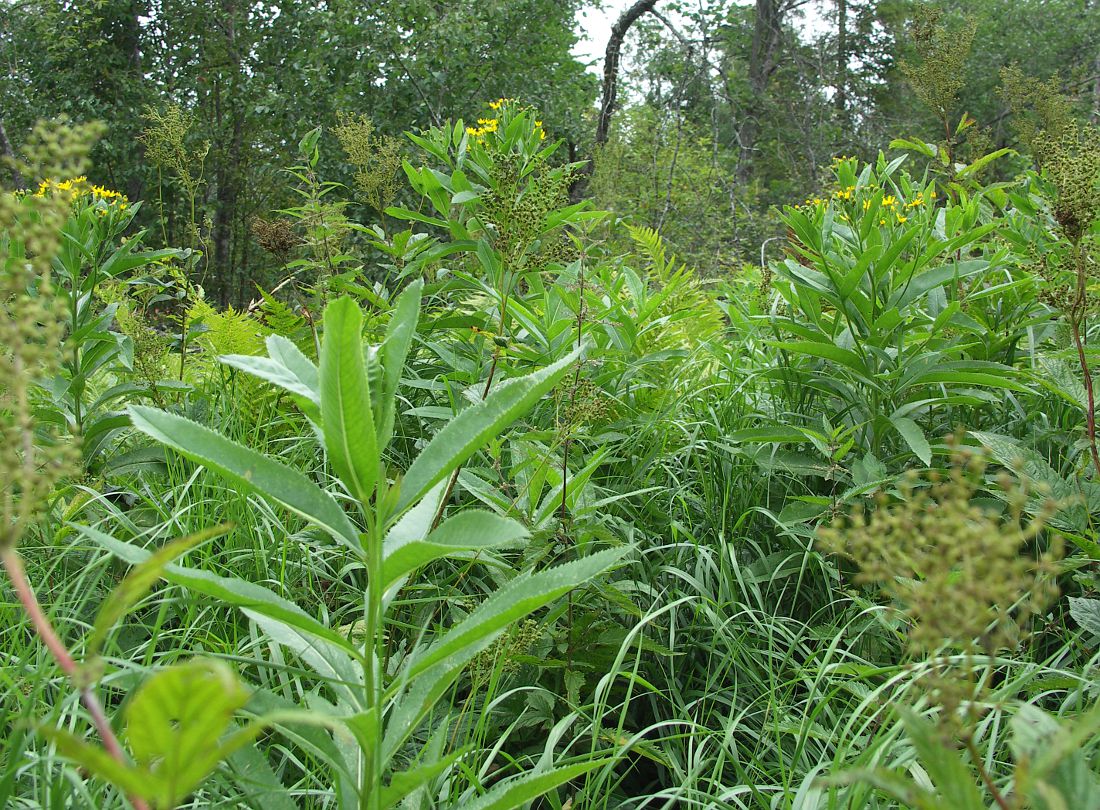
xmin=735 ymin=156 xmax=1031 ymax=490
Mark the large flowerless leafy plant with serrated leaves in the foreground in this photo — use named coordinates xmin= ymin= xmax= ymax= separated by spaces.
xmin=83 ymin=283 xmax=626 ymax=810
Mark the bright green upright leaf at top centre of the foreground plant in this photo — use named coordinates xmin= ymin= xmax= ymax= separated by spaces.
xmin=321 ymin=296 xmax=380 ymax=504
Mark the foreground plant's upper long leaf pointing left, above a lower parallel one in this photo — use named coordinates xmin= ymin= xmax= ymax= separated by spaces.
xmin=129 ymin=405 xmax=362 ymax=555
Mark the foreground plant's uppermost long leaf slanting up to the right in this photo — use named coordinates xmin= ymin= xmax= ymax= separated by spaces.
xmin=396 ymin=349 xmax=582 ymax=514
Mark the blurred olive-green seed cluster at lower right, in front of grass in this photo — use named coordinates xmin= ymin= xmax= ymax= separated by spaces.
xmin=818 ymin=450 xmax=1058 ymax=654
